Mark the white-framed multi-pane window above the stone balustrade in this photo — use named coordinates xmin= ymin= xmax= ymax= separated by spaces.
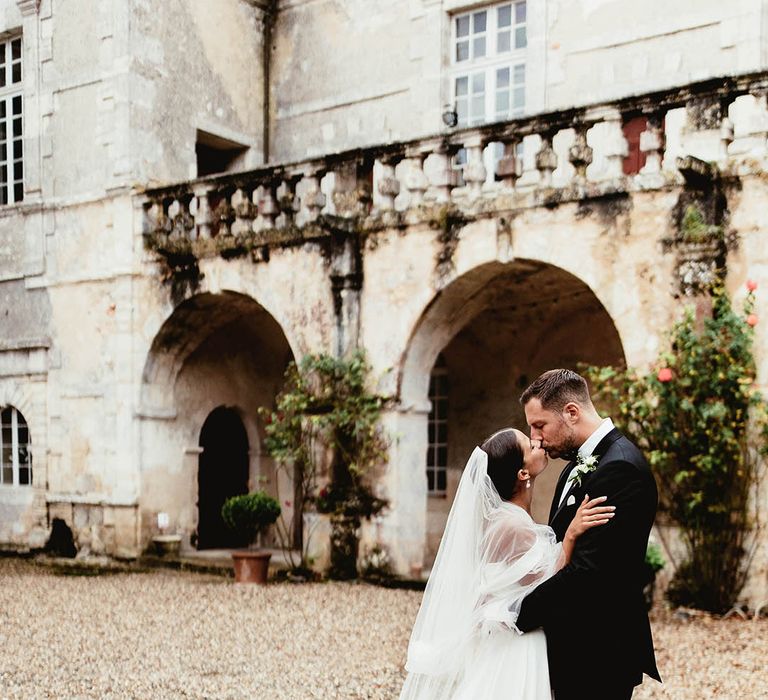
xmin=451 ymin=0 xmax=528 ymax=126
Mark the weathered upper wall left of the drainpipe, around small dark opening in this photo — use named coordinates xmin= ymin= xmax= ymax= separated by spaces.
xmin=126 ymin=0 xmax=266 ymax=184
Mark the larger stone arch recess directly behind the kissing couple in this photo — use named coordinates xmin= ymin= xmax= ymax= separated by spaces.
xmin=393 ymin=258 xmax=625 ymax=566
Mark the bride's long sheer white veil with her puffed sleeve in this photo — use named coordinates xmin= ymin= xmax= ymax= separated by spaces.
xmin=400 ymin=447 xmax=563 ymax=700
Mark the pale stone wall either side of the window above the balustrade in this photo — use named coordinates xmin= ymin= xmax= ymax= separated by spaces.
xmin=271 ymin=0 xmax=766 ymax=161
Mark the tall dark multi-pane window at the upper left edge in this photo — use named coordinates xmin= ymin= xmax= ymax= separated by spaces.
xmin=0 ymin=36 xmax=24 ymax=205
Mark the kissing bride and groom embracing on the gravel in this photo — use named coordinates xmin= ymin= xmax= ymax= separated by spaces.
xmin=400 ymin=369 xmax=660 ymax=700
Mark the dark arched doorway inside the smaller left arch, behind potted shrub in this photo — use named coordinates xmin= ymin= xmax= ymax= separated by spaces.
xmin=197 ymin=406 xmax=248 ymax=549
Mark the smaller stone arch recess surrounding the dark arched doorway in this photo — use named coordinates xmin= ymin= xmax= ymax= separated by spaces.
xmin=139 ymin=292 xmax=294 ymax=547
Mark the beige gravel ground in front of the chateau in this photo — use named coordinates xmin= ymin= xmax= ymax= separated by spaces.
xmin=0 ymin=559 xmax=768 ymax=700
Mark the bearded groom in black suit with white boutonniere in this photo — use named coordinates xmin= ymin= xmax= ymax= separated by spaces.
xmin=517 ymin=369 xmax=661 ymax=700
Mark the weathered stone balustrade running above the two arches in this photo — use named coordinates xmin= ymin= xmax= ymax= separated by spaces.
xmin=143 ymin=73 xmax=768 ymax=245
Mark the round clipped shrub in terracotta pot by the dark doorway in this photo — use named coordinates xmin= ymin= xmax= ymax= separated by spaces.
xmin=221 ymin=491 xmax=280 ymax=583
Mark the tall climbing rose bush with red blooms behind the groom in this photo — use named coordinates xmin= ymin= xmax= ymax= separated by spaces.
xmin=586 ymin=282 xmax=768 ymax=613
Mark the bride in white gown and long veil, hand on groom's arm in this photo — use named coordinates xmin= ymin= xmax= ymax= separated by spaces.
xmin=400 ymin=428 xmax=614 ymax=700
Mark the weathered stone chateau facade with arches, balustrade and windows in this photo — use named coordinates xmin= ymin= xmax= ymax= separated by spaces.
xmin=0 ymin=0 xmax=768 ymax=602
